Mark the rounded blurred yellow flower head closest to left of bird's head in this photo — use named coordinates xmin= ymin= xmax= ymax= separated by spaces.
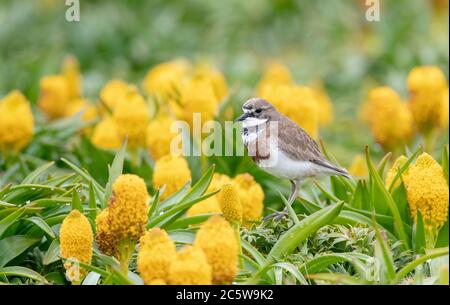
xmin=170 ymin=78 xmax=219 ymax=127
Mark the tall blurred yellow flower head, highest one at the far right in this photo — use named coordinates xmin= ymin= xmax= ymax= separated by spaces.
xmin=408 ymin=66 xmax=447 ymax=133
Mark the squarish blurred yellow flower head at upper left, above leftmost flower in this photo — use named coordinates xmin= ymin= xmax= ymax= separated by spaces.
xmin=38 ymin=75 xmax=69 ymax=119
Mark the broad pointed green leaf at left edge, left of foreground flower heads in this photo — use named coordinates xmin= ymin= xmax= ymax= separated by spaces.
xmin=0 ymin=235 xmax=41 ymax=267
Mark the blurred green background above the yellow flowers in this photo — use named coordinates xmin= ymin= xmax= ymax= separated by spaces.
xmin=0 ymin=0 xmax=449 ymax=165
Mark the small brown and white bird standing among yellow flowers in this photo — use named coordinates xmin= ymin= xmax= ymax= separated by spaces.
xmin=236 ymin=98 xmax=349 ymax=219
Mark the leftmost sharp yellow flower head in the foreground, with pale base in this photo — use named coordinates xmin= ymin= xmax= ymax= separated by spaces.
xmin=59 ymin=210 xmax=94 ymax=281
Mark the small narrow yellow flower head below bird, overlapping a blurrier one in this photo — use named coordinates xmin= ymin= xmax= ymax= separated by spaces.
xmin=217 ymin=184 xmax=242 ymax=224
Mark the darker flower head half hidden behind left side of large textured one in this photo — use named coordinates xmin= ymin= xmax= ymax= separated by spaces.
xmin=95 ymin=208 xmax=118 ymax=256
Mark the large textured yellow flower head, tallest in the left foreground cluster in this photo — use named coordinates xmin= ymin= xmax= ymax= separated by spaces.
xmin=108 ymin=174 xmax=148 ymax=241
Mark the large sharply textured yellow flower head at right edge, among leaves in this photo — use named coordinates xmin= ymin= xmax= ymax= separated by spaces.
xmin=404 ymin=153 xmax=448 ymax=229
